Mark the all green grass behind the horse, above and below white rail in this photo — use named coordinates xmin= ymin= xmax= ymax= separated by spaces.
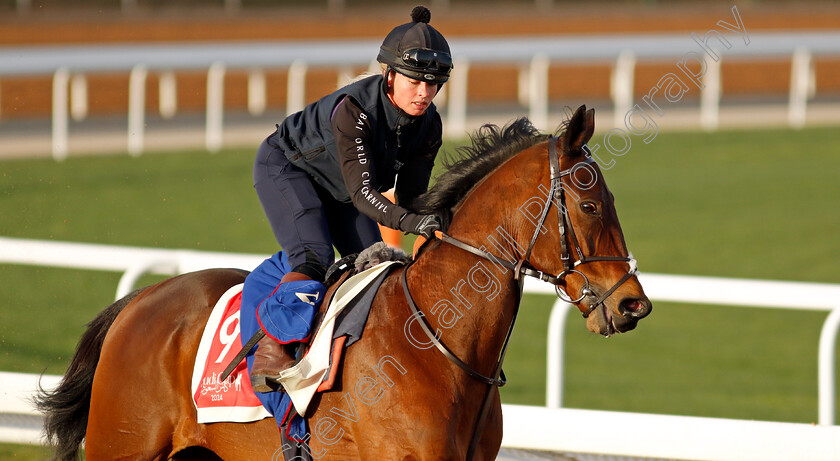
xmin=0 ymin=129 xmax=840 ymax=452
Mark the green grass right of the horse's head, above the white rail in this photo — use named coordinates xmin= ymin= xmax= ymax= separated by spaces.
xmin=605 ymin=129 xmax=840 ymax=283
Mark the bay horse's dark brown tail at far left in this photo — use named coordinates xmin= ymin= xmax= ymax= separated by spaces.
xmin=34 ymin=288 xmax=144 ymax=460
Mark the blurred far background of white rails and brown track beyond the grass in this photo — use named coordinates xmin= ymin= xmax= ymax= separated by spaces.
xmin=0 ymin=0 xmax=840 ymax=158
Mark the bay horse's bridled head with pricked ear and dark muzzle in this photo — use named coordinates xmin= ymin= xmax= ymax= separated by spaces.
xmin=531 ymin=106 xmax=652 ymax=336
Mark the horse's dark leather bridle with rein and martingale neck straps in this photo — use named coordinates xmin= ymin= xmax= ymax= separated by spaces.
xmin=402 ymin=136 xmax=638 ymax=460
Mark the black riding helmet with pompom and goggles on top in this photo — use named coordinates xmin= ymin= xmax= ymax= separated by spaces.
xmin=376 ymin=6 xmax=452 ymax=84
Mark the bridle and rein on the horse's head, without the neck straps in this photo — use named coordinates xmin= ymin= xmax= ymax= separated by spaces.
xmin=438 ymin=136 xmax=638 ymax=318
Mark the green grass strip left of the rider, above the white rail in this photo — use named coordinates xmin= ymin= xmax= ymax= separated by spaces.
xmin=0 ymin=152 xmax=276 ymax=252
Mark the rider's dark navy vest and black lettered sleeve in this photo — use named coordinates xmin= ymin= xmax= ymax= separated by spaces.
xmin=269 ymin=75 xmax=442 ymax=229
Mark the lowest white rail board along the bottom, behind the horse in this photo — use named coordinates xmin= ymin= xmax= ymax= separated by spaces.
xmin=0 ymin=372 xmax=840 ymax=461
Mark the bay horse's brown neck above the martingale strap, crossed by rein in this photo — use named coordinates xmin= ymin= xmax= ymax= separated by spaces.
xmin=409 ymin=147 xmax=544 ymax=372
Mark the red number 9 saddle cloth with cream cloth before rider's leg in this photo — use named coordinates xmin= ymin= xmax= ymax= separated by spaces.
xmin=192 ymin=261 xmax=397 ymax=423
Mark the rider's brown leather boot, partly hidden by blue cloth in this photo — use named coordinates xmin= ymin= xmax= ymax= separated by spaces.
xmin=251 ymin=272 xmax=322 ymax=392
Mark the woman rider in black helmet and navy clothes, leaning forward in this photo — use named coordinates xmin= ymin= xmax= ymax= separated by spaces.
xmin=251 ymin=6 xmax=452 ymax=392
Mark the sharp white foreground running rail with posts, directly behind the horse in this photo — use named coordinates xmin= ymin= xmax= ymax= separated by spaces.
xmin=0 ymin=237 xmax=840 ymax=461
